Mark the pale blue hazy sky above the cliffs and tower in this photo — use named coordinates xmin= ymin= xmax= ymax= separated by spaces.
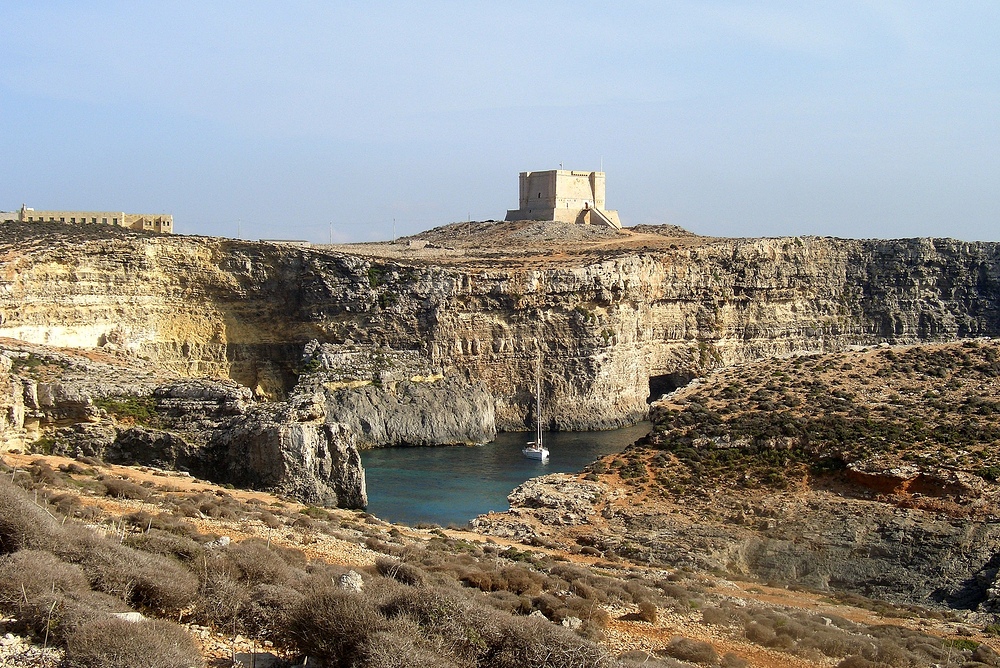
xmin=0 ymin=0 xmax=1000 ymax=242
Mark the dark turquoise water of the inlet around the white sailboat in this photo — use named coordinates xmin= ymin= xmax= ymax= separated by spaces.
xmin=361 ymin=423 xmax=649 ymax=526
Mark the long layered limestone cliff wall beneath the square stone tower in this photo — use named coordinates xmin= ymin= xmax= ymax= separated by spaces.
xmin=0 ymin=224 xmax=1000 ymax=429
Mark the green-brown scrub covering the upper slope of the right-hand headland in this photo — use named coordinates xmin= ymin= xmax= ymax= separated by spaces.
xmin=632 ymin=344 xmax=1000 ymax=493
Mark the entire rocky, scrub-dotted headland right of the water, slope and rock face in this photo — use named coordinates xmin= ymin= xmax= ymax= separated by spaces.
xmin=476 ymin=340 xmax=1000 ymax=624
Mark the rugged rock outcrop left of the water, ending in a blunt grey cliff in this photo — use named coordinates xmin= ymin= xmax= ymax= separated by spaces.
xmin=0 ymin=346 xmax=368 ymax=508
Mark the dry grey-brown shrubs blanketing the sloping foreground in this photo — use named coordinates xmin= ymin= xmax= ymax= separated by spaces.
xmin=0 ymin=448 xmax=992 ymax=668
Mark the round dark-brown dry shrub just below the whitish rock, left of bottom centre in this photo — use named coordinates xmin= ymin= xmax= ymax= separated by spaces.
xmin=287 ymin=589 xmax=389 ymax=668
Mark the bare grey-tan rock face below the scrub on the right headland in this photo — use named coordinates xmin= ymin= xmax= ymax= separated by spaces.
xmin=472 ymin=474 xmax=1000 ymax=611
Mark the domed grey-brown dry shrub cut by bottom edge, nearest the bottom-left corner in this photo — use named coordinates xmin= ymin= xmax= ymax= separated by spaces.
xmin=66 ymin=618 xmax=204 ymax=668
